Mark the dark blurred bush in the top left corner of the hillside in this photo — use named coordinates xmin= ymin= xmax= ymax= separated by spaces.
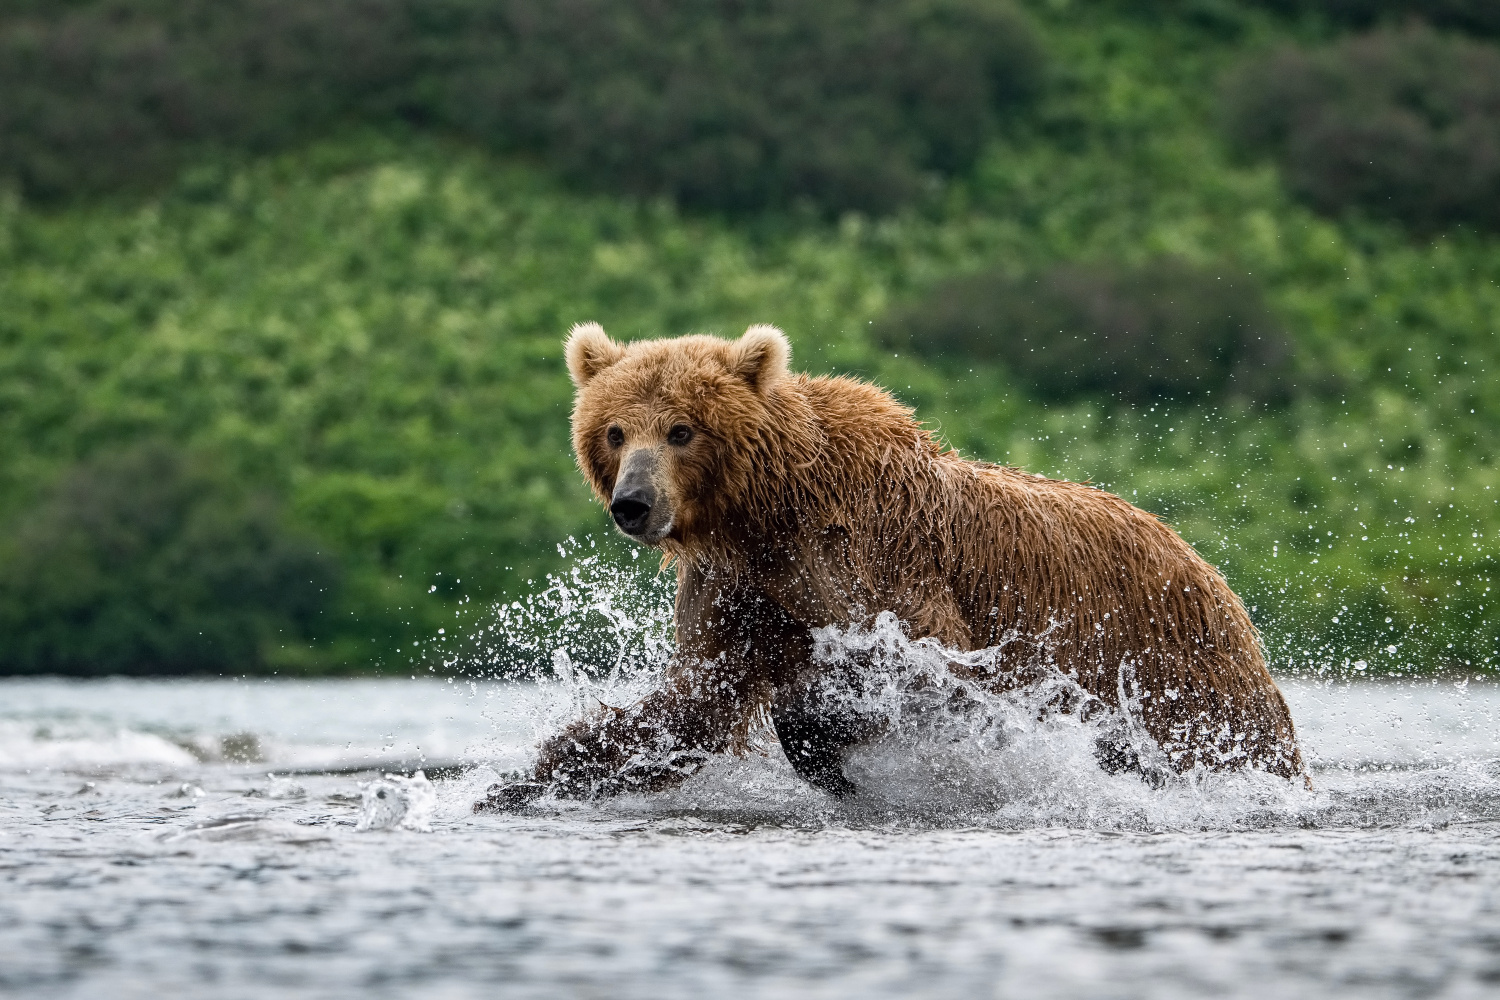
xmin=0 ymin=0 xmax=416 ymax=198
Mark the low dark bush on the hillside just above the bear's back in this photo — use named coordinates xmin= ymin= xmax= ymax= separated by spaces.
xmin=876 ymin=258 xmax=1290 ymax=402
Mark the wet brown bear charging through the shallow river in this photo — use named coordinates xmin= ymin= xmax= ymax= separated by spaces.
xmin=476 ymin=324 xmax=1302 ymax=810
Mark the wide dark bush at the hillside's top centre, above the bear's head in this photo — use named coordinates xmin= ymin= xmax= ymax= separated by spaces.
xmin=444 ymin=0 xmax=1040 ymax=211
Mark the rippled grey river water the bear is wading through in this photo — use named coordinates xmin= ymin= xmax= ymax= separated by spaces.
xmin=0 ymin=671 xmax=1500 ymax=999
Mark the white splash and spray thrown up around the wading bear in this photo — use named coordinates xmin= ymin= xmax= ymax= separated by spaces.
xmin=461 ymin=543 xmax=1500 ymax=831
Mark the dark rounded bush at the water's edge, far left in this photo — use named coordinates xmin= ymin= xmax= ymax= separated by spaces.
xmin=0 ymin=444 xmax=338 ymax=675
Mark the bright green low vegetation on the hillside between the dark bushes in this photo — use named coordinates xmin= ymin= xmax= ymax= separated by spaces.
xmin=0 ymin=0 xmax=1500 ymax=672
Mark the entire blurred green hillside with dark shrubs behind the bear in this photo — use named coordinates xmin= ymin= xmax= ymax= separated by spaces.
xmin=0 ymin=0 xmax=1500 ymax=675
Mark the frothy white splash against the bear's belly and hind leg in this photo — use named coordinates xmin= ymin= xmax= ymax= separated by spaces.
xmin=681 ymin=613 xmax=1311 ymax=829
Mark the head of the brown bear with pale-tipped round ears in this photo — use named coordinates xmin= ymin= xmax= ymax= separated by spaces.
xmin=567 ymin=322 xmax=797 ymax=550
